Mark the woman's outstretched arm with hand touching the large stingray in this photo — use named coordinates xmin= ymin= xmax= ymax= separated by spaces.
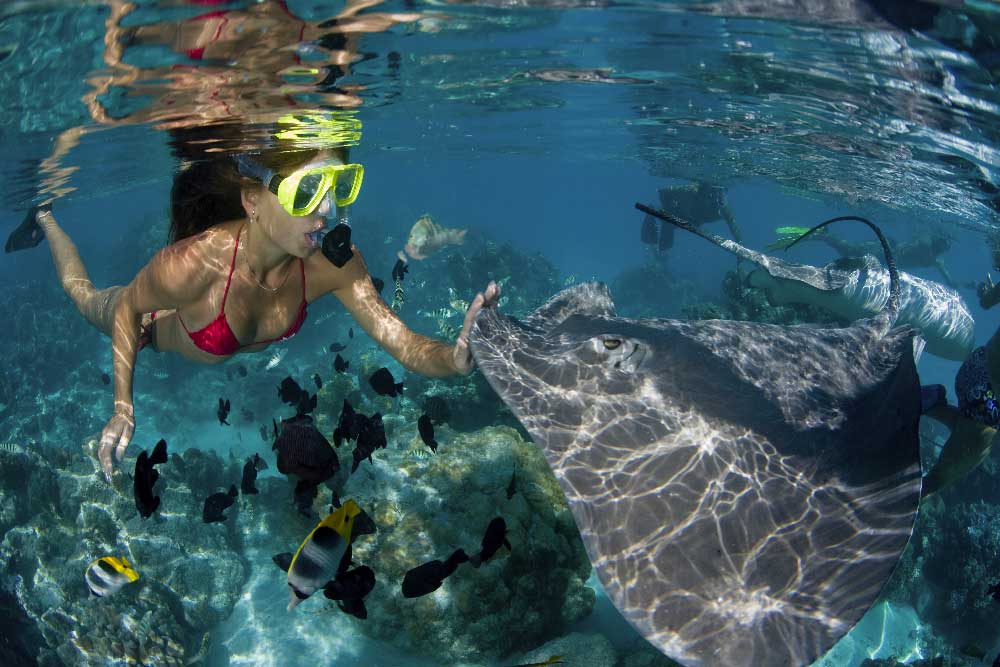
xmin=322 ymin=247 xmax=500 ymax=377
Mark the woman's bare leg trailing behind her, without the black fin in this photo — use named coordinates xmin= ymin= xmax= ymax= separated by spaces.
xmin=38 ymin=212 xmax=122 ymax=336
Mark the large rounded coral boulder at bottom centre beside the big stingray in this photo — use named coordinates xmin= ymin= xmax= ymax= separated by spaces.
xmin=345 ymin=427 xmax=595 ymax=660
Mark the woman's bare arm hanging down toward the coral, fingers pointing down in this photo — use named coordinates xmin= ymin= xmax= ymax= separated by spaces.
xmin=97 ymin=238 xmax=217 ymax=480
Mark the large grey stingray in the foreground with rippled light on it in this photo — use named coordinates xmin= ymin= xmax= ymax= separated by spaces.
xmin=470 ymin=217 xmax=920 ymax=667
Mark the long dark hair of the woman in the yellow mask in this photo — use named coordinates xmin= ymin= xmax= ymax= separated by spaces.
xmin=170 ymin=150 xmax=319 ymax=243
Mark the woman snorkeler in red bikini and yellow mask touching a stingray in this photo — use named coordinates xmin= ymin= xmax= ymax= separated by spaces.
xmin=6 ymin=144 xmax=500 ymax=480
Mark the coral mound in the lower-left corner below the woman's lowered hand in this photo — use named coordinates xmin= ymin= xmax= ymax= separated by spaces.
xmin=0 ymin=440 xmax=247 ymax=665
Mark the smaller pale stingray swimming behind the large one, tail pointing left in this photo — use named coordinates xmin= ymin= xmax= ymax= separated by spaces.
xmin=636 ymin=204 xmax=975 ymax=361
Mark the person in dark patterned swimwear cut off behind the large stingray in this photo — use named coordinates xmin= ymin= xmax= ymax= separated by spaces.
xmin=921 ymin=344 xmax=1000 ymax=497
